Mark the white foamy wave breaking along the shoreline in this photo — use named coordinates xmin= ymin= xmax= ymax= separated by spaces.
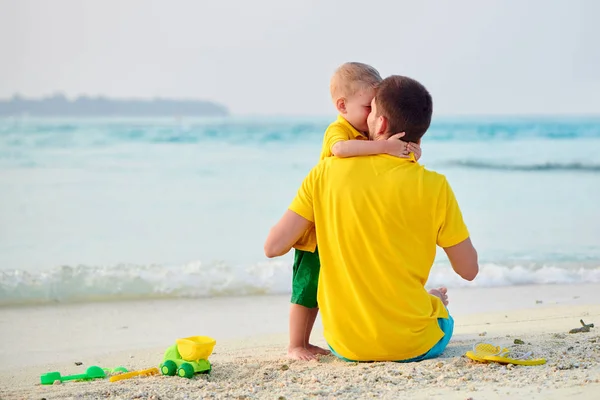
xmin=0 ymin=261 xmax=600 ymax=306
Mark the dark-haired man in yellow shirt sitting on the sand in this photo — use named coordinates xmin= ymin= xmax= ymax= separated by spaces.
xmin=265 ymin=76 xmax=479 ymax=361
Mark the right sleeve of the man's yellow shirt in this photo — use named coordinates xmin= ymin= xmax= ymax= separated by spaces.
xmin=437 ymin=178 xmax=469 ymax=247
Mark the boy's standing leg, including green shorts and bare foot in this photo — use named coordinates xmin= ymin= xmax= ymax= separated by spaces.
xmin=288 ymin=250 xmax=329 ymax=360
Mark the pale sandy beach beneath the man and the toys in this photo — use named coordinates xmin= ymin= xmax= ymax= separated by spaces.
xmin=0 ymin=284 xmax=600 ymax=400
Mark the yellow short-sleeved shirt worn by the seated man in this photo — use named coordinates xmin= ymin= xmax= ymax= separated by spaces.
xmin=290 ymin=155 xmax=469 ymax=361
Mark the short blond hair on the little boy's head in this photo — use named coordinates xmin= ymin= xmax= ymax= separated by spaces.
xmin=329 ymin=62 xmax=382 ymax=102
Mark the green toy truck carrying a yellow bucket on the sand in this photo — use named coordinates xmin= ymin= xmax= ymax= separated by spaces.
xmin=160 ymin=336 xmax=217 ymax=378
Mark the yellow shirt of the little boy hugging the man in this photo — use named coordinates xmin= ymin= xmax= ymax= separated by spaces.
xmin=294 ymin=115 xmax=369 ymax=253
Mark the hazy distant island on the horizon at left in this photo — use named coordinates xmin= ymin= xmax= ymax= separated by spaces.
xmin=0 ymin=94 xmax=229 ymax=117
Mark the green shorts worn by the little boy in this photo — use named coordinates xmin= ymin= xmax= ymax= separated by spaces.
xmin=292 ymin=249 xmax=321 ymax=308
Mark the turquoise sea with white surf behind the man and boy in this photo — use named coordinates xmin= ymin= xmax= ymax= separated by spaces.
xmin=0 ymin=118 xmax=600 ymax=305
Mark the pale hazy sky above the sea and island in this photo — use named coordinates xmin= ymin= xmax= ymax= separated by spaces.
xmin=0 ymin=0 xmax=600 ymax=116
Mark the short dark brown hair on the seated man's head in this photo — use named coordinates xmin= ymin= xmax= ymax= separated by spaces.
xmin=375 ymin=75 xmax=433 ymax=143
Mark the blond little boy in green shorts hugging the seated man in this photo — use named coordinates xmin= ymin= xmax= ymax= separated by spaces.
xmin=288 ymin=62 xmax=421 ymax=360
